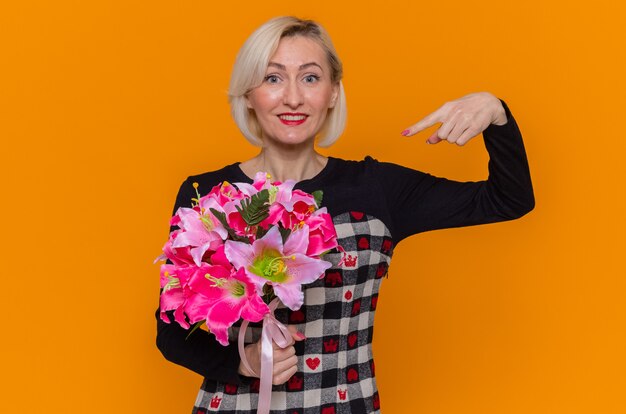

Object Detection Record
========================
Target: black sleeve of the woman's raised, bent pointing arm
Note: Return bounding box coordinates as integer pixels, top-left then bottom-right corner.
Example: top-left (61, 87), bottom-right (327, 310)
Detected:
top-left (375, 101), bottom-right (535, 243)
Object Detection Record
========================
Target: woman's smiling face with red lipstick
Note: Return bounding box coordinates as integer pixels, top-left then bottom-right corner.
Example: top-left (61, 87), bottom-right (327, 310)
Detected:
top-left (247, 36), bottom-right (339, 146)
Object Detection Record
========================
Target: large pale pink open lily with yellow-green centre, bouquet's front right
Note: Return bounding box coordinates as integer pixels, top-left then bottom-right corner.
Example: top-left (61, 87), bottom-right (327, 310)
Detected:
top-left (224, 226), bottom-right (331, 310)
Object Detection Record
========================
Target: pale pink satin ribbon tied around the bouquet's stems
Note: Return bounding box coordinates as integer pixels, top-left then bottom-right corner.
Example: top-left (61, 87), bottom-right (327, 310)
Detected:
top-left (239, 298), bottom-right (292, 414)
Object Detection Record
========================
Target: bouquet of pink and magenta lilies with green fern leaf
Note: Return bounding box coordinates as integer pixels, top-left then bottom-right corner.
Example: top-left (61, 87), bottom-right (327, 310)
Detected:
top-left (157, 173), bottom-right (337, 349)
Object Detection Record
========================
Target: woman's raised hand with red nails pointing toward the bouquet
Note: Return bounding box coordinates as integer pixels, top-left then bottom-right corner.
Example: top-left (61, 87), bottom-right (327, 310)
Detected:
top-left (402, 92), bottom-right (507, 145)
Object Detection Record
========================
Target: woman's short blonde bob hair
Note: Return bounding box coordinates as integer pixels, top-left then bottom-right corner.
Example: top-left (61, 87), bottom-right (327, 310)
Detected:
top-left (228, 16), bottom-right (346, 147)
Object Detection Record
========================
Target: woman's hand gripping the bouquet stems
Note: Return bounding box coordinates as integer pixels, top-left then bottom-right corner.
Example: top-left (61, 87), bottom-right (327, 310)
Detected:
top-left (239, 325), bottom-right (305, 385)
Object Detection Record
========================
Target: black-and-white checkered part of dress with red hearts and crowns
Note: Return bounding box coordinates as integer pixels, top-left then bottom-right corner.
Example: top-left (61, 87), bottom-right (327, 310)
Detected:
top-left (192, 211), bottom-right (393, 414)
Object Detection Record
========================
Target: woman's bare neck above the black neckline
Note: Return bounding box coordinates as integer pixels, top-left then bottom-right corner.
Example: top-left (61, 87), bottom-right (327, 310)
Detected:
top-left (240, 147), bottom-right (328, 181)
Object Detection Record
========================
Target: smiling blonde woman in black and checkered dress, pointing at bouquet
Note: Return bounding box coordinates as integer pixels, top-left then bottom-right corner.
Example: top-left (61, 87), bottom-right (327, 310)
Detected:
top-left (157, 17), bottom-right (534, 414)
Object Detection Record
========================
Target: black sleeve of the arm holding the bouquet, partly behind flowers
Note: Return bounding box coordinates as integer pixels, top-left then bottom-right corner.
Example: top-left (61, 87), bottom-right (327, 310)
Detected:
top-left (156, 179), bottom-right (241, 384)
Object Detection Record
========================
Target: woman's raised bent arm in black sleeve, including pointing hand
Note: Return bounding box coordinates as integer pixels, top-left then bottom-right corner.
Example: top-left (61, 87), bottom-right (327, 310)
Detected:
top-left (376, 93), bottom-right (535, 243)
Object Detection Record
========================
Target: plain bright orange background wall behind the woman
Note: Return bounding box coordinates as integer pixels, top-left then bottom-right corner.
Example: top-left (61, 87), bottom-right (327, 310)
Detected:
top-left (0, 0), bottom-right (626, 414)
